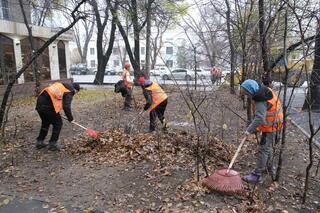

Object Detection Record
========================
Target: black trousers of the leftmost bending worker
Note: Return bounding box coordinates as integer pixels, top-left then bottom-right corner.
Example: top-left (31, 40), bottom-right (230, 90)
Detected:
top-left (37, 110), bottom-right (62, 142)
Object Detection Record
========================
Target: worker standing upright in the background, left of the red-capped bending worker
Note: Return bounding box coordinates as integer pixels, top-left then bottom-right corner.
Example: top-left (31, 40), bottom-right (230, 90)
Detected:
top-left (121, 63), bottom-right (133, 111)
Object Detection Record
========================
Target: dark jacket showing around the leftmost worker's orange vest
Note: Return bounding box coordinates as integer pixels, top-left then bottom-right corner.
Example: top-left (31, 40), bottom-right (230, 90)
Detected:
top-left (36, 83), bottom-right (75, 121)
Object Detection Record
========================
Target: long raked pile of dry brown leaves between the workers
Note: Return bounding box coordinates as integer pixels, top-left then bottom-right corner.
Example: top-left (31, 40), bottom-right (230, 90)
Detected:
top-left (68, 129), bottom-right (235, 170)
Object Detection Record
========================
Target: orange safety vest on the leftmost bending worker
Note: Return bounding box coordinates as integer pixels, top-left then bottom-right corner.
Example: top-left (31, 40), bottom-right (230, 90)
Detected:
top-left (40, 82), bottom-right (70, 113)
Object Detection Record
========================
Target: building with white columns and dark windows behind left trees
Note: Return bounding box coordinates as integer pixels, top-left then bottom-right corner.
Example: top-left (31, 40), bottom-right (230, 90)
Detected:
top-left (0, 0), bottom-right (73, 85)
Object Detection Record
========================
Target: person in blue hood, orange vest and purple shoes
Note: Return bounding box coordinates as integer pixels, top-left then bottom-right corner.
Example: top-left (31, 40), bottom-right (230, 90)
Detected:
top-left (240, 79), bottom-right (283, 183)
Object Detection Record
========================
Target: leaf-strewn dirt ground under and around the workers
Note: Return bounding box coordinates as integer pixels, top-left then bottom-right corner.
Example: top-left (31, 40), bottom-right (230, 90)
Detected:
top-left (0, 88), bottom-right (320, 212)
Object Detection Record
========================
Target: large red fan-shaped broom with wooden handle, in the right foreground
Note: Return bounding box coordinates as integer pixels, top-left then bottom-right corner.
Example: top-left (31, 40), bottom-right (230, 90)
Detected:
top-left (203, 137), bottom-right (247, 194)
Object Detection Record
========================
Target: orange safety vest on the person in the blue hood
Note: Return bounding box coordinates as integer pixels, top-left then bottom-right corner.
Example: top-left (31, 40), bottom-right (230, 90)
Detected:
top-left (257, 88), bottom-right (283, 132)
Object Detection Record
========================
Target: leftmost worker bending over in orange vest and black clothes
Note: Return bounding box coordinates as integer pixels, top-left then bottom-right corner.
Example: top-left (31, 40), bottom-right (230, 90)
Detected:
top-left (36, 82), bottom-right (80, 151)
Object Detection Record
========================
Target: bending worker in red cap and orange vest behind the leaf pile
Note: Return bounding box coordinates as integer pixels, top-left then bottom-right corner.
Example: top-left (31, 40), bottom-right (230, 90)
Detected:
top-left (138, 76), bottom-right (168, 132)
